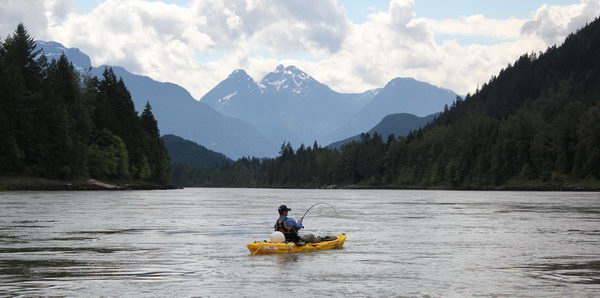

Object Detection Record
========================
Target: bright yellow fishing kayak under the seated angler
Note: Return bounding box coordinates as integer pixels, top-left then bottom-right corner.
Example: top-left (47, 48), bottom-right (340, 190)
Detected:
top-left (248, 234), bottom-right (347, 255)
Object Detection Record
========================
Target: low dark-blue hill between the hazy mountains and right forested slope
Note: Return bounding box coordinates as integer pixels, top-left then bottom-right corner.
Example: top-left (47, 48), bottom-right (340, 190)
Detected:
top-left (327, 113), bottom-right (437, 149)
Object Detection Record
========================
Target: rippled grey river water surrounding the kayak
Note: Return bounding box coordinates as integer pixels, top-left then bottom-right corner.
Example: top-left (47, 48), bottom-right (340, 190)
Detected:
top-left (0, 189), bottom-right (600, 297)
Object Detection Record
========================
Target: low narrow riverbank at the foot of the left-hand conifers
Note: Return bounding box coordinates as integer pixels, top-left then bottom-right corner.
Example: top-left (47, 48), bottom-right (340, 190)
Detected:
top-left (0, 177), bottom-right (178, 191)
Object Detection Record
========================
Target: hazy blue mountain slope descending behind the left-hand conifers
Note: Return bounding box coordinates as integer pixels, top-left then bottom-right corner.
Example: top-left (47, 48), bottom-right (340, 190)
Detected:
top-left (37, 41), bottom-right (278, 158)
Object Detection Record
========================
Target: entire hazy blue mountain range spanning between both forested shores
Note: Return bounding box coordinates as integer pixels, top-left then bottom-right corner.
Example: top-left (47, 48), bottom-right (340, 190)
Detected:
top-left (36, 41), bottom-right (456, 159)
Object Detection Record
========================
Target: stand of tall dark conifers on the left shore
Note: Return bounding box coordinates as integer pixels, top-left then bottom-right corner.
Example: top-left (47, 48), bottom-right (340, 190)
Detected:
top-left (0, 25), bottom-right (169, 184)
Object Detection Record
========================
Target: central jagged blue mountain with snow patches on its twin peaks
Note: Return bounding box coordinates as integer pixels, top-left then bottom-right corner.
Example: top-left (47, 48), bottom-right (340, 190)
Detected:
top-left (201, 65), bottom-right (376, 145)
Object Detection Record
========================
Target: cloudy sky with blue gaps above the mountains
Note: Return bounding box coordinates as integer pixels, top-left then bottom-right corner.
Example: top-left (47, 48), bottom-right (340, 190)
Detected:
top-left (0, 0), bottom-right (600, 99)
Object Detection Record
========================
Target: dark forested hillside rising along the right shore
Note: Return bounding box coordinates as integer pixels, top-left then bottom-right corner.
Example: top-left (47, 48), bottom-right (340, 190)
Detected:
top-left (177, 20), bottom-right (600, 189)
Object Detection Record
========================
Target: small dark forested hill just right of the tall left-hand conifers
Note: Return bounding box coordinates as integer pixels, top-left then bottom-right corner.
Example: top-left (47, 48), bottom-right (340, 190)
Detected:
top-left (161, 135), bottom-right (233, 166)
